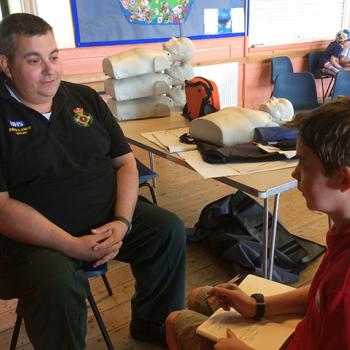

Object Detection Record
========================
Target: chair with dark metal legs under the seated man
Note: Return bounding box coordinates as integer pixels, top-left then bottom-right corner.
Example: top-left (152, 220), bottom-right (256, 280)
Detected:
top-left (10, 262), bottom-right (114, 350)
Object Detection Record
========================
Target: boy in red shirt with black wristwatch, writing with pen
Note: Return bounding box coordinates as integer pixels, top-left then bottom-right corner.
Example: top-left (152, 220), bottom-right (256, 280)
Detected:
top-left (167, 99), bottom-right (350, 350)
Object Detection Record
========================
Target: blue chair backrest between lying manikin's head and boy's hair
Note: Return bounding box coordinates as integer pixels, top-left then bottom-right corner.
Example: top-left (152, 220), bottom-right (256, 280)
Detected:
top-left (272, 72), bottom-right (319, 111)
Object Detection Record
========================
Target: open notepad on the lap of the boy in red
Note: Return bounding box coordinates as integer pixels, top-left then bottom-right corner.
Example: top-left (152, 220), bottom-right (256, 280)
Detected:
top-left (196, 275), bottom-right (302, 350)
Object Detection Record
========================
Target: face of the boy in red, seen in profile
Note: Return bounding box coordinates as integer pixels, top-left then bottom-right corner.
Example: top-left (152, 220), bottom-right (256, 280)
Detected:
top-left (292, 139), bottom-right (339, 214)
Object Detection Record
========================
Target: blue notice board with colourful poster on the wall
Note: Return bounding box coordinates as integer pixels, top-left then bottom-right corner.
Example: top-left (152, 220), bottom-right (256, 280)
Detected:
top-left (71, 0), bottom-right (245, 47)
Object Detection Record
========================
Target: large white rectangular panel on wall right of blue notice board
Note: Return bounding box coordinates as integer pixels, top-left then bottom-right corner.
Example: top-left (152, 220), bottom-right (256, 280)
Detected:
top-left (249, 0), bottom-right (349, 46)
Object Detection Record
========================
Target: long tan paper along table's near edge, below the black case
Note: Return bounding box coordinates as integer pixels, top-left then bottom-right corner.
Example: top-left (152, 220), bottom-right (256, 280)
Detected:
top-left (179, 150), bottom-right (297, 179)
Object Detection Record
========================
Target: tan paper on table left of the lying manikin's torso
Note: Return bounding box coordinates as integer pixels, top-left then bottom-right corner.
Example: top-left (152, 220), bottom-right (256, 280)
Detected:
top-left (141, 127), bottom-right (197, 153)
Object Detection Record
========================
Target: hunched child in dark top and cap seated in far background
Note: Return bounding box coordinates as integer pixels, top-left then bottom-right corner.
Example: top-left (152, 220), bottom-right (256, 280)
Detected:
top-left (319, 31), bottom-right (347, 76)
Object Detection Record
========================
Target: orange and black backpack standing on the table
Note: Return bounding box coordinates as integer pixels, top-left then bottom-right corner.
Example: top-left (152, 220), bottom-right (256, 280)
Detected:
top-left (182, 77), bottom-right (220, 120)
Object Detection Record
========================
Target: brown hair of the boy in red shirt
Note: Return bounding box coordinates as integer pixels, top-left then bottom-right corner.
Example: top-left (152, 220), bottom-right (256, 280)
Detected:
top-left (286, 98), bottom-right (350, 176)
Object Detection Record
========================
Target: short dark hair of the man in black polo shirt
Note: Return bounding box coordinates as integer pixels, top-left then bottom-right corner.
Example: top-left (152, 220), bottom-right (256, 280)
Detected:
top-left (0, 13), bottom-right (53, 61)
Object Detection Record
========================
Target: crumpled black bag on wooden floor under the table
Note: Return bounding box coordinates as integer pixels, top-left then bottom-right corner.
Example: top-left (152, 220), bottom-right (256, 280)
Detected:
top-left (187, 191), bottom-right (325, 283)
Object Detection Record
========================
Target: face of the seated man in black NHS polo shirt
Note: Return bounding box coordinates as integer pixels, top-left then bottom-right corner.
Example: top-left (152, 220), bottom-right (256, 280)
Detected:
top-left (4, 32), bottom-right (62, 106)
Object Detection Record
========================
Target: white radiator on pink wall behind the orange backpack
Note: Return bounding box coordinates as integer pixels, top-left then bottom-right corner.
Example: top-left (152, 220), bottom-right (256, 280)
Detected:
top-left (193, 62), bottom-right (238, 108)
